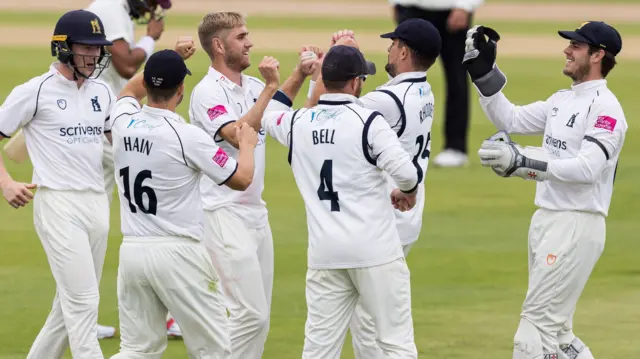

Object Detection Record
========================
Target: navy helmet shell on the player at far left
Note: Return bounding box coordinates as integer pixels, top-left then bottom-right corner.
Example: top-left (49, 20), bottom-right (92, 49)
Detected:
top-left (52, 10), bottom-right (113, 46)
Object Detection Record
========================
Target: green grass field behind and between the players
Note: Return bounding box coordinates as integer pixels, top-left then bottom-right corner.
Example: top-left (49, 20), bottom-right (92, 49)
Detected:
top-left (0, 8), bottom-right (640, 359)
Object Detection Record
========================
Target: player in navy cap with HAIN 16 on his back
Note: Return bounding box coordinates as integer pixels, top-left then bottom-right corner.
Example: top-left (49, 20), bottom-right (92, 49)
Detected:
top-left (110, 46), bottom-right (258, 359)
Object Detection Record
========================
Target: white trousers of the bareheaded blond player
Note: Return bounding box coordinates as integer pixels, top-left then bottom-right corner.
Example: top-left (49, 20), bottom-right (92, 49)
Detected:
top-left (202, 208), bottom-right (273, 359)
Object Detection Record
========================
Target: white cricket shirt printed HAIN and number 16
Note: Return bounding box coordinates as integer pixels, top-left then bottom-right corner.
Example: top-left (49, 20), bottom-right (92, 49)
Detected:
top-left (110, 97), bottom-right (238, 240)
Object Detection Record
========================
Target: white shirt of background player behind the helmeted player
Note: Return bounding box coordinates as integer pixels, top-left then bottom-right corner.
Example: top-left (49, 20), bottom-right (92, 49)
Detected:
top-left (86, 0), bottom-right (135, 95)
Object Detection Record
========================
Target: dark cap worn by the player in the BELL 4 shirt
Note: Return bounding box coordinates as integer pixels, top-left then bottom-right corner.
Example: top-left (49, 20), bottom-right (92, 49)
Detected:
top-left (322, 45), bottom-right (376, 81)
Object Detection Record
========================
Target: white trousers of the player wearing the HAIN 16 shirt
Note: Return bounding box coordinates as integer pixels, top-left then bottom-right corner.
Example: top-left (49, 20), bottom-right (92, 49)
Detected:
top-left (111, 237), bottom-right (231, 359)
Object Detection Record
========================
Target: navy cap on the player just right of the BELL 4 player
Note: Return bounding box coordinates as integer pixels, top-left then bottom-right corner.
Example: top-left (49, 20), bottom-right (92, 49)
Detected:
top-left (380, 18), bottom-right (442, 58)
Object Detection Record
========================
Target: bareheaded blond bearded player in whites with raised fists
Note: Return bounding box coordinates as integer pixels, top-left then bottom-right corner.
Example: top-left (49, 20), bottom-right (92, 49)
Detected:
top-left (189, 12), bottom-right (313, 359)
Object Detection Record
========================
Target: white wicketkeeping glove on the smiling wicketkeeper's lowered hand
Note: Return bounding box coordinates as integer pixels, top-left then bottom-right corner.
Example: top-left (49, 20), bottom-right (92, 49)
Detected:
top-left (478, 131), bottom-right (548, 181)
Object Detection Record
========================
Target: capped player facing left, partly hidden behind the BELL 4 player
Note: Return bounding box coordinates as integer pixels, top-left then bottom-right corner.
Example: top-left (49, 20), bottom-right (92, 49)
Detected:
top-left (309, 19), bottom-right (442, 358)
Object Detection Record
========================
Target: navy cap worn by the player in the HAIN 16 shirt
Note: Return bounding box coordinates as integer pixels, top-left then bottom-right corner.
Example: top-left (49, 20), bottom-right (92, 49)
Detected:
top-left (144, 50), bottom-right (191, 89)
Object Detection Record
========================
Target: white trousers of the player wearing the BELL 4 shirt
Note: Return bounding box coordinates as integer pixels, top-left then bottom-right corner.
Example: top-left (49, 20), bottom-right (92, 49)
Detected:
top-left (302, 258), bottom-right (418, 359)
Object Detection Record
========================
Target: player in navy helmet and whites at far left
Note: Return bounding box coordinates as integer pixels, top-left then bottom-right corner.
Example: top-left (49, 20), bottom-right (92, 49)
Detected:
top-left (0, 10), bottom-right (115, 359)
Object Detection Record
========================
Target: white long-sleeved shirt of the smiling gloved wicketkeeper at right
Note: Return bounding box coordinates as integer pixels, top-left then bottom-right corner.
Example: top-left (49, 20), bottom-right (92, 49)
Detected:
top-left (480, 80), bottom-right (628, 216)
